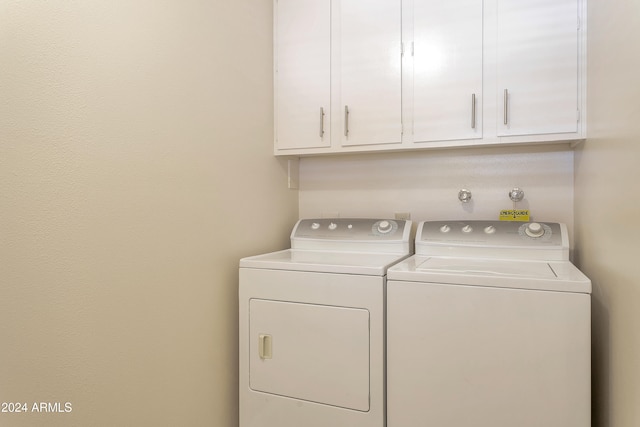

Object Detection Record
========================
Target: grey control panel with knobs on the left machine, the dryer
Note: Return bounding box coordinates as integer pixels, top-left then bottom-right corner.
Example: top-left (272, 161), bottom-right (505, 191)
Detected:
top-left (291, 218), bottom-right (410, 241)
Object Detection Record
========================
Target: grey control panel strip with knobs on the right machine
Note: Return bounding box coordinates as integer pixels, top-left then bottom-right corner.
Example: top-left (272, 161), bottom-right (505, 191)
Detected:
top-left (418, 221), bottom-right (563, 247)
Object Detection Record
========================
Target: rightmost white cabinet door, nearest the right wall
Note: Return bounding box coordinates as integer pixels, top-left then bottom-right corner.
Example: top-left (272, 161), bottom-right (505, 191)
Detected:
top-left (497, 0), bottom-right (578, 136)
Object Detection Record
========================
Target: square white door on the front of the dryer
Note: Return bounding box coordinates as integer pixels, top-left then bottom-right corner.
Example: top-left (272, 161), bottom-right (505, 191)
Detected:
top-left (249, 299), bottom-right (369, 411)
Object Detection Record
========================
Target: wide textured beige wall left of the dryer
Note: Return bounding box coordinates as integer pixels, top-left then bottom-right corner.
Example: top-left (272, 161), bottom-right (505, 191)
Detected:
top-left (0, 0), bottom-right (297, 427)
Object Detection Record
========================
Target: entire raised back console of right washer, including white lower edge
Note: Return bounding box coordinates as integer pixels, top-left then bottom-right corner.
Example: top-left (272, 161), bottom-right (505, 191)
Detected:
top-left (416, 220), bottom-right (569, 260)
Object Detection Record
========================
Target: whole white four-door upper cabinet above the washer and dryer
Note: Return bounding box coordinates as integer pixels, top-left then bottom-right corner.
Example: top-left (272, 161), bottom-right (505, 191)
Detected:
top-left (274, 0), bottom-right (587, 155)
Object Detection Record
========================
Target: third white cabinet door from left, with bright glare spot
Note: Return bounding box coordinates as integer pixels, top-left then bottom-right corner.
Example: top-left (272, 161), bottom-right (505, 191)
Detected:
top-left (413, 0), bottom-right (482, 142)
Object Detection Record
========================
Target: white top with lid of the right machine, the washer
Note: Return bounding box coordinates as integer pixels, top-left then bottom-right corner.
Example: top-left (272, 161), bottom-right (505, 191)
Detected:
top-left (387, 255), bottom-right (591, 293)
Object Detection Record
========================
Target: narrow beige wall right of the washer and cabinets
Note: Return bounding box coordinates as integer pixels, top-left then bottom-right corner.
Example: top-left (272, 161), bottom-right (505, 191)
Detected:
top-left (575, 0), bottom-right (640, 427)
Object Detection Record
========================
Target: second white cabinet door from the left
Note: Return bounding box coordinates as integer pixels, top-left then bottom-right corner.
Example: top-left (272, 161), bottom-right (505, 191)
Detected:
top-left (336, 0), bottom-right (402, 146)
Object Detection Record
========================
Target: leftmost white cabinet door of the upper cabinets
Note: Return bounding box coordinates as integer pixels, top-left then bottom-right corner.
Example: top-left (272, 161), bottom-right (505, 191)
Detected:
top-left (275, 0), bottom-right (331, 150)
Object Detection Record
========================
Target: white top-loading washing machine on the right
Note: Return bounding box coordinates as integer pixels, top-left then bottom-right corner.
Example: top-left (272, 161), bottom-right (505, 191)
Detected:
top-left (387, 221), bottom-right (591, 427)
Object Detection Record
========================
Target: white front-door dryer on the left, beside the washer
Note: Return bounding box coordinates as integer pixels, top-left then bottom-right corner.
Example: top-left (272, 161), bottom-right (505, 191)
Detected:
top-left (239, 219), bottom-right (411, 427)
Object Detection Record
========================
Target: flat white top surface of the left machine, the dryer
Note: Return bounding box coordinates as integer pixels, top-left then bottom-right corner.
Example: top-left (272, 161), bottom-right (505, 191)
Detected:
top-left (240, 249), bottom-right (408, 276)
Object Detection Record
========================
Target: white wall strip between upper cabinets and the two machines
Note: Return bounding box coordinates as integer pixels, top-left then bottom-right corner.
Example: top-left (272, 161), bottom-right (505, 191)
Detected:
top-left (300, 144), bottom-right (573, 241)
